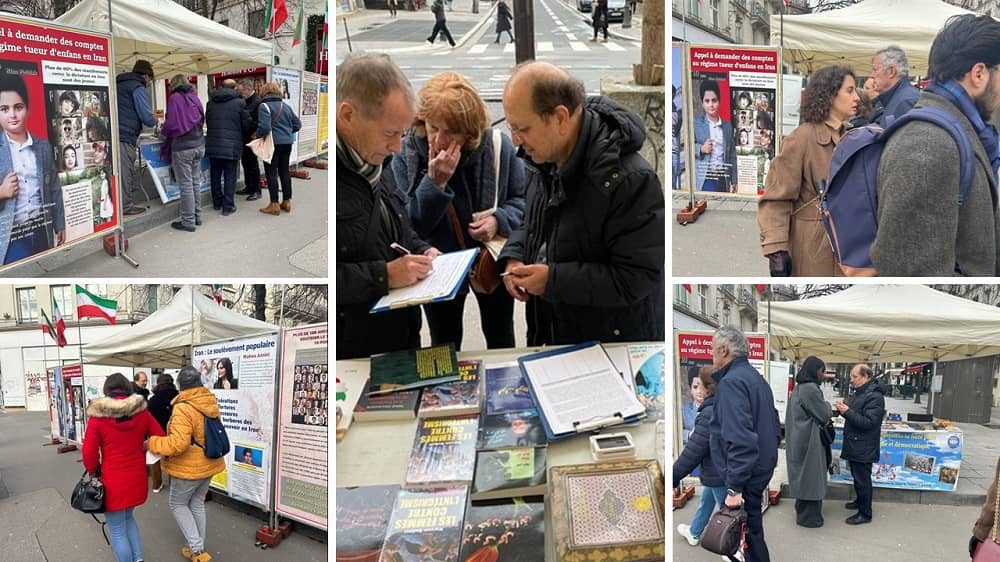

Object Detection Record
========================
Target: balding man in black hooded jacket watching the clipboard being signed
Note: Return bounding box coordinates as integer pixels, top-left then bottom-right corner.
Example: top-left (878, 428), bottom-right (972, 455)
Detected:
top-left (498, 61), bottom-right (665, 345)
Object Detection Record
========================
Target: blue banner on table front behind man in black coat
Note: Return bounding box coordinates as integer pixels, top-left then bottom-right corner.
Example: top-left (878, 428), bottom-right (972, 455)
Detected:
top-left (830, 427), bottom-right (963, 492)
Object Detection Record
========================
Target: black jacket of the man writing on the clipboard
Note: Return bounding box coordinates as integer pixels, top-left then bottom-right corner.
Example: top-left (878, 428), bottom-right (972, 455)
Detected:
top-left (335, 150), bottom-right (430, 359)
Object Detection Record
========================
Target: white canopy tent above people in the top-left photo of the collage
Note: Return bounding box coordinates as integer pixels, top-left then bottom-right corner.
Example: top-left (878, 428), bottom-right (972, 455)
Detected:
top-left (56, 0), bottom-right (272, 78)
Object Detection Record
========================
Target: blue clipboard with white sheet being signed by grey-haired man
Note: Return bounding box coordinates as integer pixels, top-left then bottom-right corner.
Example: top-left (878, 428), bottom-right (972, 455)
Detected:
top-left (370, 248), bottom-right (479, 313)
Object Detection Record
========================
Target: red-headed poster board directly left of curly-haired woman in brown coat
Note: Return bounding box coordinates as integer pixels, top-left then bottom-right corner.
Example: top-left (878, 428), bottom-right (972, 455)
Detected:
top-left (683, 45), bottom-right (781, 195)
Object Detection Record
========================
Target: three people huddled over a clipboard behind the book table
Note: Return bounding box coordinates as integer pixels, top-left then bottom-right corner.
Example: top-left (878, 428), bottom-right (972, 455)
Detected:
top-left (336, 53), bottom-right (665, 358)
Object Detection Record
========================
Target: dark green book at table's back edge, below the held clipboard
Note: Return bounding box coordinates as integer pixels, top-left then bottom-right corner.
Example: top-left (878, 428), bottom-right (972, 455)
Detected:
top-left (368, 343), bottom-right (459, 394)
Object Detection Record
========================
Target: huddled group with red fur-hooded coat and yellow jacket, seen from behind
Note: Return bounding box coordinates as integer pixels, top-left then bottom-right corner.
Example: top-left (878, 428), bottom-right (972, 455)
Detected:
top-left (83, 366), bottom-right (226, 562)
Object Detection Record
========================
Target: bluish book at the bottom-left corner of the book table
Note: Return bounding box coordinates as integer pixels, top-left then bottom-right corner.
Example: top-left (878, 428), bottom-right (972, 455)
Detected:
top-left (336, 484), bottom-right (399, 562)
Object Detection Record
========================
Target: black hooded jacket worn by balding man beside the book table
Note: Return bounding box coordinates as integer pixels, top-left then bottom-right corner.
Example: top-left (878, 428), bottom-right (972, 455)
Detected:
top-left (498, 96), bottom-right (665, 345)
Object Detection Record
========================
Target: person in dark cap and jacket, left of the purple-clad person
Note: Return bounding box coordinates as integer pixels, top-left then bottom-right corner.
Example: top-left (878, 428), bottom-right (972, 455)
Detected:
top-left (115, 59), bottom-right (156, 215)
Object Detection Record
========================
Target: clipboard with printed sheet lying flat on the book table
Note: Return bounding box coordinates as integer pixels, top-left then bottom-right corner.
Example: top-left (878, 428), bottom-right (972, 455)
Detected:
top-left (517, 342), bottom-right (646, 441)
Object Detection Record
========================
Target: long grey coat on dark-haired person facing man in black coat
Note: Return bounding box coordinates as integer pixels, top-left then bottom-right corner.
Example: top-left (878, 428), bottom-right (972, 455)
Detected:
top-left (785, 383), bottom-right (833, 501)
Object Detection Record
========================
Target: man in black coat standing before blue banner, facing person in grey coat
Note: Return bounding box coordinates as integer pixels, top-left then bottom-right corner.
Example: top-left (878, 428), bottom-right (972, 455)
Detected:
top-left (834, 363), bottom-right (885, 525)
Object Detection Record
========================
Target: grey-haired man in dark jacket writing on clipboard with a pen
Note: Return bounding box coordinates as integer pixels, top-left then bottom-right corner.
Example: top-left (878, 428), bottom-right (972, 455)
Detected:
top-left (336, 53), bottom-right (440, 359)
